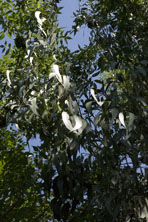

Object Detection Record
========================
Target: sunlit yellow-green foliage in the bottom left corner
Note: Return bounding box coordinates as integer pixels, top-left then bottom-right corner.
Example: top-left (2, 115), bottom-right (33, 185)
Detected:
top-left (0, 129), bottom-right (51, 222)
